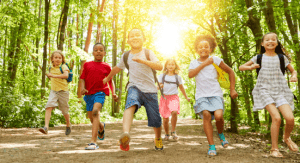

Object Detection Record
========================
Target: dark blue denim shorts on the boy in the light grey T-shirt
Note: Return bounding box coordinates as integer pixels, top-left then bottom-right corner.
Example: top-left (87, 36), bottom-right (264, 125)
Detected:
top-left (125, 86), bottom-right (161, 128)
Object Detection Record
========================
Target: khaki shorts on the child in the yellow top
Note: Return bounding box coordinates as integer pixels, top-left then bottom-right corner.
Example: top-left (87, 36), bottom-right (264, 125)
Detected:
top-left (45, 90), bottom-right (69, 115)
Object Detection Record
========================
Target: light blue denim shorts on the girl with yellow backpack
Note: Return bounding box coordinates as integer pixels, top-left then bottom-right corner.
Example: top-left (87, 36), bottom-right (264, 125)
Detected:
top-left (194, 96), bottom-right (224, 120)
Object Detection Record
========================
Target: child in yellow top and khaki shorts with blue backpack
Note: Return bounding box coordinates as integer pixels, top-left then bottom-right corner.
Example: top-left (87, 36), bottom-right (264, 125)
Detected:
top-left (39, 50), bottom-right (71, 135)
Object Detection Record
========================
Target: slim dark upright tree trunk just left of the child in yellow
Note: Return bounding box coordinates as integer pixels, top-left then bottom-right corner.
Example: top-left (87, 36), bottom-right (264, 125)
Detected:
top-left (41, 0), bottom-right (50, 99)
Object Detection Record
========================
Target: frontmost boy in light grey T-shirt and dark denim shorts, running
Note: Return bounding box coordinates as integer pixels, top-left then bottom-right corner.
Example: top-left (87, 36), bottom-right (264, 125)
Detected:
top-left (103, 28), bottom-right (163, 151)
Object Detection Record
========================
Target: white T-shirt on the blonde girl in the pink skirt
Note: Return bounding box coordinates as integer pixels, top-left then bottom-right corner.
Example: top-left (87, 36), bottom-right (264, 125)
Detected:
top-left (158, 74), bottom-right (182, 95)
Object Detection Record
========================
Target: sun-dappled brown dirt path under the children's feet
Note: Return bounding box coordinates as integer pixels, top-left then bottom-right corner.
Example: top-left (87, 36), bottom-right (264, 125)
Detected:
top-left (0, 119), bottom-right (300, 163)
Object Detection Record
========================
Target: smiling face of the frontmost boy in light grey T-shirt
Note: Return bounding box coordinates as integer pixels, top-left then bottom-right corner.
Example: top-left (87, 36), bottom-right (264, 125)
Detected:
top-left (127, 29), bottom-right (145, 49)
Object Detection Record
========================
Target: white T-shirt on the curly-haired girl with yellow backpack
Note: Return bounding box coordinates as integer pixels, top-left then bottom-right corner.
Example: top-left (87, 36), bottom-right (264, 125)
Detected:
top-left (189, 56), bottom-right (223, 100)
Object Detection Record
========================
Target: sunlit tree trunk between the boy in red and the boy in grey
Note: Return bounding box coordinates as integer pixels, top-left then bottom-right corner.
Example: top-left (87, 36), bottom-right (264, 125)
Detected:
top-left (112, 0), bottom-right (119, 116)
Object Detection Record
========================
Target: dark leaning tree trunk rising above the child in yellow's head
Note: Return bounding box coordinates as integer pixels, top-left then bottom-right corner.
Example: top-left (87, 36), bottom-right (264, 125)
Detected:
top-left (57, 0), bottom-right (70, 51)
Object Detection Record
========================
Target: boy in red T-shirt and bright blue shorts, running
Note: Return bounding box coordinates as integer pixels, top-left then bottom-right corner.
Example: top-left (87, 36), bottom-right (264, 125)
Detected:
top-left (80, 43), bottom-right (118, 150)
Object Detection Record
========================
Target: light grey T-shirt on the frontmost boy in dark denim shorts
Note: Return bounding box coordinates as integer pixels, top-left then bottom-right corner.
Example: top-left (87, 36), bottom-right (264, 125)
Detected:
top-left (117, 49), bottom-right (159, 93)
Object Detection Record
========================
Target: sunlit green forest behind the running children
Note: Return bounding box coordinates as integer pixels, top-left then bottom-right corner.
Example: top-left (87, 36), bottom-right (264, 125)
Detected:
top-left (0, 0), bottom-right (300, 139)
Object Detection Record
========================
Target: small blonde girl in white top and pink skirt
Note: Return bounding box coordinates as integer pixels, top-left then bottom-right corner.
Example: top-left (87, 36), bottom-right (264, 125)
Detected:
top-left (158, 59), bottom-right (190, 141)
